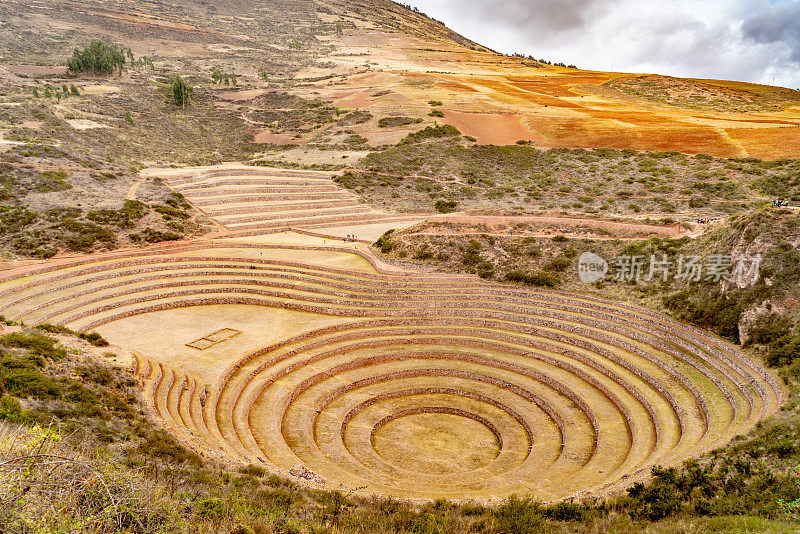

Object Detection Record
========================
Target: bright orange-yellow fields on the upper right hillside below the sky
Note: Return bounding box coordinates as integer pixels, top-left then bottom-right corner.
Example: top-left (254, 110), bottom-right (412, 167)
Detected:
top-left (301, 34), bottom-right (800, 159)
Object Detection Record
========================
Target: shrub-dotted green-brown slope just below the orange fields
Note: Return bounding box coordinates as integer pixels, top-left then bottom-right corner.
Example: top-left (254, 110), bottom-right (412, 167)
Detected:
top-left (347, 143), bottom-right (760, 220)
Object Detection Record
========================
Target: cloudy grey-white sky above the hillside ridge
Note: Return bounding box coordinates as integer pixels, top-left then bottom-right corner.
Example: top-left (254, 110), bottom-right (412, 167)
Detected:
top-left (405, 0), bottom-right (800, 88)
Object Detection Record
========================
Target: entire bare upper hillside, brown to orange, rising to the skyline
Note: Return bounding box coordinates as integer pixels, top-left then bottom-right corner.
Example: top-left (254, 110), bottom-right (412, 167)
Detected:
top-left (0, 0), bottom-right (800, 159)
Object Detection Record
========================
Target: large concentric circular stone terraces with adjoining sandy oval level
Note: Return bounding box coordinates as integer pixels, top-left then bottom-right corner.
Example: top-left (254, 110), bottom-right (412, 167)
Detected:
top-left (0, 242), bottom-right (781, 500)
